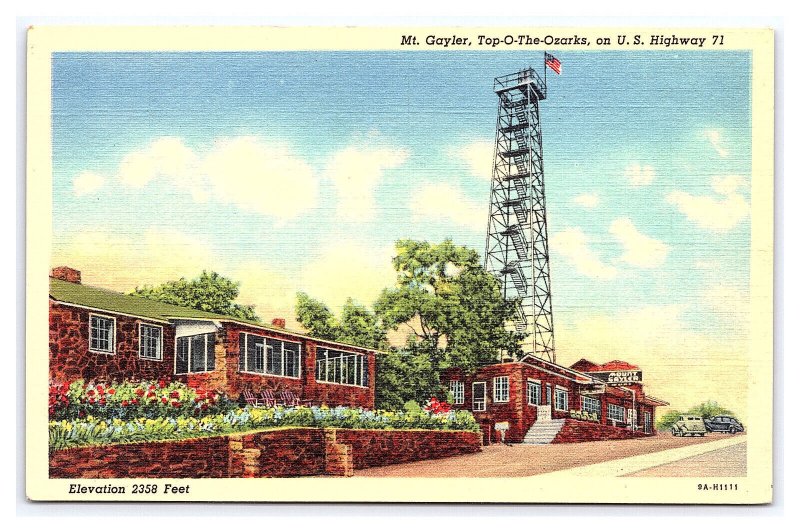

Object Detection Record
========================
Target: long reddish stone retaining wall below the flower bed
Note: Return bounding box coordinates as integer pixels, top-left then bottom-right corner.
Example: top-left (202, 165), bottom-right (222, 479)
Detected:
top-left (50, 428), bottom-right (481, 478)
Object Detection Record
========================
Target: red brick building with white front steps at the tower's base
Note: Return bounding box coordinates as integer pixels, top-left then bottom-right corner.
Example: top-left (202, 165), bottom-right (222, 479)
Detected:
top-left (442, 356), bottom-right (668, 443)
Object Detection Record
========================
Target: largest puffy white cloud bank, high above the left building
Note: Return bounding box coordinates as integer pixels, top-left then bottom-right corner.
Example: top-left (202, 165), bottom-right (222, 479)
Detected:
top-left (82, 137), bottom-right (318, 220)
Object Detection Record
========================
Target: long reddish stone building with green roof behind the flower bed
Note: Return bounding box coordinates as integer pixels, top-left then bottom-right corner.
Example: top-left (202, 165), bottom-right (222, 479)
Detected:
top-left (49, 267), bottom-right (377, 408)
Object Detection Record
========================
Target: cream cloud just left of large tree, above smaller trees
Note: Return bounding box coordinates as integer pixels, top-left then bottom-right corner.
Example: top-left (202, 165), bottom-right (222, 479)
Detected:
top-left (292, 241), bottom-right (396, 313)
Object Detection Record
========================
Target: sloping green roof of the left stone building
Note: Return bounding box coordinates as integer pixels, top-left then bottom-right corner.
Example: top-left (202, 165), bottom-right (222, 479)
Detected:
top-left (50, 277), bottom-right (245, 327)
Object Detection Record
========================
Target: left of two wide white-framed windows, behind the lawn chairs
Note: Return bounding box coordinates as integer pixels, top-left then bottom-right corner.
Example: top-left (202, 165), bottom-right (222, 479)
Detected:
top-left (239, 333), bottom-right (300, 377)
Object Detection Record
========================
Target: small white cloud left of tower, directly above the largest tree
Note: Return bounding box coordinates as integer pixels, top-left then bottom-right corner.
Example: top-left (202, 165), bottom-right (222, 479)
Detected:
top-left (409, 184), bottom-right (488, 230)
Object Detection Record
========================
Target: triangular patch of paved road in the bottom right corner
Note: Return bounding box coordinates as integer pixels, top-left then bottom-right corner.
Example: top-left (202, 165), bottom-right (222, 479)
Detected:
top-left (625, 443), bottom-right (747, 477)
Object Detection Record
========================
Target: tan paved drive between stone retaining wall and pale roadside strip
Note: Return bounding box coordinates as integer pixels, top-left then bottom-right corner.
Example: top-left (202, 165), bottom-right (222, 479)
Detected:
top-left (355, 433), bottom-right (738, 477)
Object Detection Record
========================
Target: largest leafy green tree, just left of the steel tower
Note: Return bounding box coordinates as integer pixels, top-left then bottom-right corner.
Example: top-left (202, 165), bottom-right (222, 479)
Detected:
top-left (375, 240), bottom-right (522, 372)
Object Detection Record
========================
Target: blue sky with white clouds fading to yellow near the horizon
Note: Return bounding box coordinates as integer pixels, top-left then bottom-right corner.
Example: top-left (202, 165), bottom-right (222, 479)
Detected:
top-left (52, 50), bottom-right (751, 412)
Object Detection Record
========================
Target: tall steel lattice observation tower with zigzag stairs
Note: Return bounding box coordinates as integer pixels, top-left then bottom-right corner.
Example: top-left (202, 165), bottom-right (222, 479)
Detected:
top-left (485, 68), bottom-right (555, 362)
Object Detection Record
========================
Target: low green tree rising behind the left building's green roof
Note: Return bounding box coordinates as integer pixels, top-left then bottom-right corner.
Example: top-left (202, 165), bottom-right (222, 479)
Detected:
top-left (131, 270), bottom-right (260, 321)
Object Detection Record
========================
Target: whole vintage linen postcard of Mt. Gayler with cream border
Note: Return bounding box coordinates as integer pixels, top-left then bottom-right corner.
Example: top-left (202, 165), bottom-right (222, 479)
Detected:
top-left (26, 26), bottom-right (774, 504)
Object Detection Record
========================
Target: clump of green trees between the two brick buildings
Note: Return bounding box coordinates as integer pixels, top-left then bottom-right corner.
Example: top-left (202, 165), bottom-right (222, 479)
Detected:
top-left (296, 240), bottom-right (521, 409)
